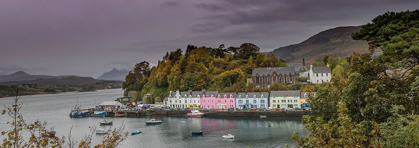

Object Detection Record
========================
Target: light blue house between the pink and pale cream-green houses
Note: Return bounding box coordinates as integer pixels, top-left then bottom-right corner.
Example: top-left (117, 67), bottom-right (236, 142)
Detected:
top-left (236, 92), bottom-right (269, 109)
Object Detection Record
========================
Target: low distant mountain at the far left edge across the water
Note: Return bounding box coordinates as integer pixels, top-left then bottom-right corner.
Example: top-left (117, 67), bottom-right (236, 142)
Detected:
top-left (0, 71), bottom-right (54, 82)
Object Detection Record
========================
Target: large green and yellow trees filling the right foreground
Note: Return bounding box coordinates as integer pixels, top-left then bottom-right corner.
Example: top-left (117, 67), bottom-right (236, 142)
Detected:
top-left (293, 10), bottom-right (419, 147)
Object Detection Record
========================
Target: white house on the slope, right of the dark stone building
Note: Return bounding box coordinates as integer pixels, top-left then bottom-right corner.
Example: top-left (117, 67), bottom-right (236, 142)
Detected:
top-left (308, 65), bottom-right (332, 84)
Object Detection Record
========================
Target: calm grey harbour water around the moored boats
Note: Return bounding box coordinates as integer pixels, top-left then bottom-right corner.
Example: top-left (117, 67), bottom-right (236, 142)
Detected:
top-left (0, 89), bottom-right (308, 148)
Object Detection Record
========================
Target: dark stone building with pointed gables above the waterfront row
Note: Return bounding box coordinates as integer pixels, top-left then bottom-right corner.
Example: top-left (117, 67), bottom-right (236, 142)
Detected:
top-left (252, 67), bottom-right (297, 88)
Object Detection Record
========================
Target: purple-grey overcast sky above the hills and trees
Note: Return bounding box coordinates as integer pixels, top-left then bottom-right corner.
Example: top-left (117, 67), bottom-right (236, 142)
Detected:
top-left (0, 0), bottom-right (419, 78)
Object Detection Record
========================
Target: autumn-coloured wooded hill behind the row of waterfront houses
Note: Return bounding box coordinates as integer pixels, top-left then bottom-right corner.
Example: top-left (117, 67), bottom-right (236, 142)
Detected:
top-left (122, 43), bottom-right (287, 101)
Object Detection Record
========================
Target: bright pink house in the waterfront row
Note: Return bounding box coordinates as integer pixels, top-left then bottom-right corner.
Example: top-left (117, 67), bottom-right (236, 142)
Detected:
top-left (200, 91), bottom-right (236, 109)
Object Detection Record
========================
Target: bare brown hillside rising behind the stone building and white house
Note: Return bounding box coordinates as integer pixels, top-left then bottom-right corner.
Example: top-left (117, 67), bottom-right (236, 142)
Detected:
top-left (267, 26), bottom-right (378, 63)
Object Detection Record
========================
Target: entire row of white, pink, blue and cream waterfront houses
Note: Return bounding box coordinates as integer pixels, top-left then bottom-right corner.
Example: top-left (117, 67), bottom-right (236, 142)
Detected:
top-left (164, 91), bottom-right (315, 110)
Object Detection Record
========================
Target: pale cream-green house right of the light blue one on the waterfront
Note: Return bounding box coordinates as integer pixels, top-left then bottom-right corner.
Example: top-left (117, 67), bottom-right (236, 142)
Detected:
top-left (269, 90), bottom-right (301, 108)
